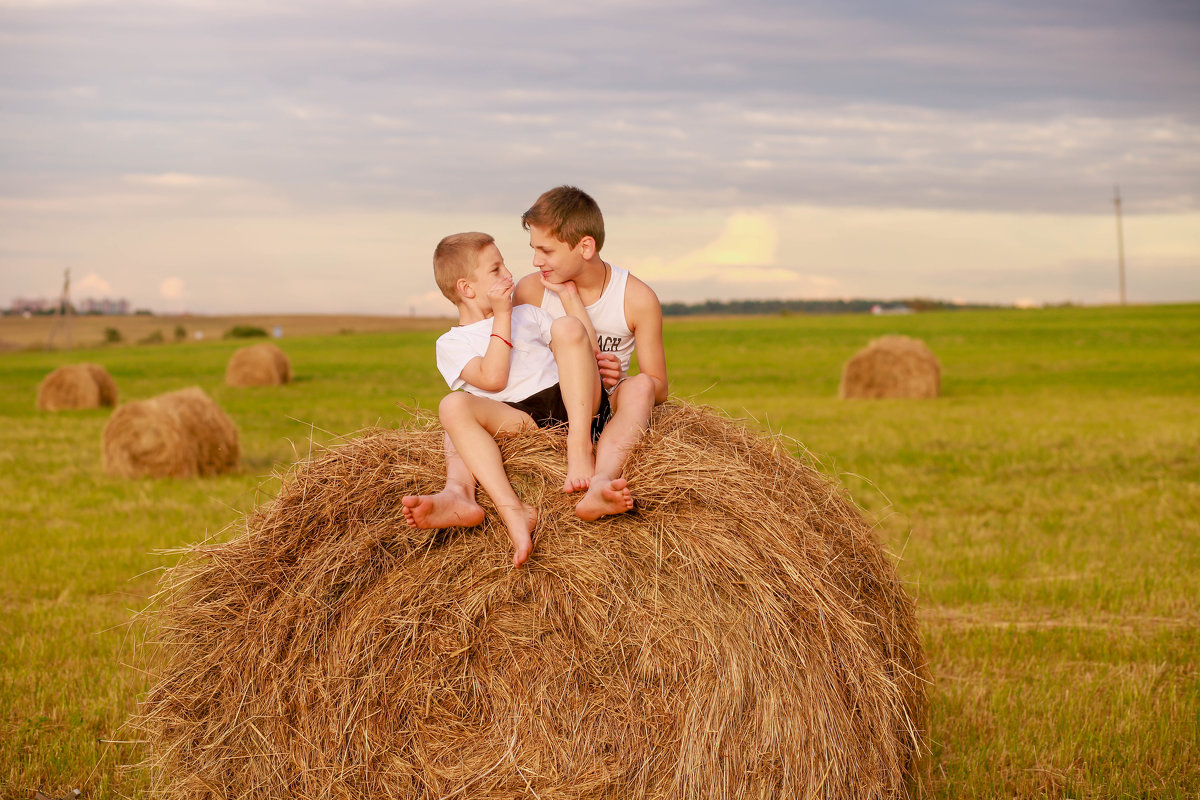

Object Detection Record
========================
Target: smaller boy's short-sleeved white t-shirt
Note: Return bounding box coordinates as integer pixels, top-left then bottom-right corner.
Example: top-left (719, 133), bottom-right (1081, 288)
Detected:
top-left (436, 305), bottom-right (558, 403)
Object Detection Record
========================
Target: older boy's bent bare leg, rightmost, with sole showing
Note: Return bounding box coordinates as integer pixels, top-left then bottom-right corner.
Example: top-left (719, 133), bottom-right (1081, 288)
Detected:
top-left (575, 375), bottom-right (654, 521)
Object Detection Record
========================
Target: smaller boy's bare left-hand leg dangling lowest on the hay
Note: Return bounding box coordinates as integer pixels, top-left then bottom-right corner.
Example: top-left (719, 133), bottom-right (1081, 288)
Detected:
top-left (438, 392), bottom-right (538, 566)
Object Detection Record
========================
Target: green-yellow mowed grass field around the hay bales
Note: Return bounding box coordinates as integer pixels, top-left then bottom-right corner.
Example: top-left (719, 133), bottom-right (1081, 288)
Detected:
top-left (0, 305), bottom-right (1200, 799)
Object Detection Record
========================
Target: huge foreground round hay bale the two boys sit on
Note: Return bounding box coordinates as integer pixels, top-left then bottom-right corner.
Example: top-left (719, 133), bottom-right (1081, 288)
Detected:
top-left (136, 405), bottom-right (928, 800)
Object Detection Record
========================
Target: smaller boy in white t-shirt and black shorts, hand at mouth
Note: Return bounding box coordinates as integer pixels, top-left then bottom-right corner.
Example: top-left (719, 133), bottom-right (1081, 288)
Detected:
top-left (402, 233), bottom-right (607, 567)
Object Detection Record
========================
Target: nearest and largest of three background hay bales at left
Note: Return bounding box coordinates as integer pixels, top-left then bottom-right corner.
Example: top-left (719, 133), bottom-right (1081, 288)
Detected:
top-left (103, 386), bottom-right (240, 477)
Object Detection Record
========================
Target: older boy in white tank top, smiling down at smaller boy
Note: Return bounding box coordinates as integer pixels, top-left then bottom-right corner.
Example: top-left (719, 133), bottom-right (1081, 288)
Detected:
top-left (515, 186), bottom-right (667, 519)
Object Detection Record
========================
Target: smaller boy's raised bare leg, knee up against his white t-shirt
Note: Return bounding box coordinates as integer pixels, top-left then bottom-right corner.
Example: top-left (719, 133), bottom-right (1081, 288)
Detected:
top-left (550, 317), bottom-right (601, 492)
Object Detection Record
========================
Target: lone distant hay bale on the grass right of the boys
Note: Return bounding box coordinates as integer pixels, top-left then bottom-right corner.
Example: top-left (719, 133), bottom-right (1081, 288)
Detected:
top-left (838, 336), bottom-right (942, 399)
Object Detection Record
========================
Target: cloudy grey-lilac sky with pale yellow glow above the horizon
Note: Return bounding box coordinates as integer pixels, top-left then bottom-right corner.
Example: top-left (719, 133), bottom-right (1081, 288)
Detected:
top-left (0, 0), bottom-right (1200, 314)
